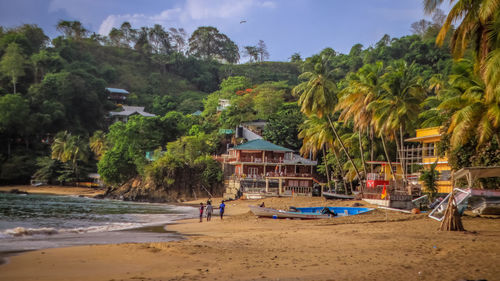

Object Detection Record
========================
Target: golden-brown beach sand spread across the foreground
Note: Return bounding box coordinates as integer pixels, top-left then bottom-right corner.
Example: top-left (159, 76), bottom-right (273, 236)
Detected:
top-left (0, 187), bottom-right (500, 281)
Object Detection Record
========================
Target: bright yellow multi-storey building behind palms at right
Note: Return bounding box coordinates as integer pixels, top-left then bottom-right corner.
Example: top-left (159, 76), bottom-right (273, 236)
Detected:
top-left (406, 127), bottom-right (452, 193)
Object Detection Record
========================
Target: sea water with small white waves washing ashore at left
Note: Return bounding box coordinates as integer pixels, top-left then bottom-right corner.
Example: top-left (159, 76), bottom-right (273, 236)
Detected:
top-left (0, 193), bottom-right (197, 252)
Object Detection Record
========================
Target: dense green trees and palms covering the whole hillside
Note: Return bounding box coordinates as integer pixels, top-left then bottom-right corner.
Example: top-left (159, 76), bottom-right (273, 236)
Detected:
top-left (0, 1), bottom-right (500, 195)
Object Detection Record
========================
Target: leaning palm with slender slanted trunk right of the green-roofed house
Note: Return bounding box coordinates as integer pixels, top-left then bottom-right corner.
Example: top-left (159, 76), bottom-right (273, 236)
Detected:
top-left (293, 54), bottom-right (363, 187)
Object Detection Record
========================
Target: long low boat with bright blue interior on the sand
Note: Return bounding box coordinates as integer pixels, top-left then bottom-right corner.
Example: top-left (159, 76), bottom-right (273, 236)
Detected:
top-left (249, 203), bottom-right (373, 219)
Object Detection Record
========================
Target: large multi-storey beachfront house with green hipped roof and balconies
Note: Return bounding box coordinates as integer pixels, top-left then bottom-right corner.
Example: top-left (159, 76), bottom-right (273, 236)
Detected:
top-left (215, 139), bottom-right (317, 199)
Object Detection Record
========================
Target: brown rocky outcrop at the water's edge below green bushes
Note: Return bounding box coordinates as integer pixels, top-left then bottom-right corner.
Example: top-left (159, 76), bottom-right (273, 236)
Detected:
top-left (104, 169), bottom-right (224, 203)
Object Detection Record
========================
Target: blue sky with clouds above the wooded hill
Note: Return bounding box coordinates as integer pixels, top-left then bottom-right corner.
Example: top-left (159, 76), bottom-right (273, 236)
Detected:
top-left (0, 0), bottom-right (447, 61)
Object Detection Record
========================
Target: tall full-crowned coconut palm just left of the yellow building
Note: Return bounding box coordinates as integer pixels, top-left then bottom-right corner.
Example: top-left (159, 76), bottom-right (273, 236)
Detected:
top-left (367, 60), bottom-right (425, 181)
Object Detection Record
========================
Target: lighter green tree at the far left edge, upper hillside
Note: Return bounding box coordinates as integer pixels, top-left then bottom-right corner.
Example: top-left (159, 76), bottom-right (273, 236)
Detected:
top-left (0, 43), bottom-right (26, 94)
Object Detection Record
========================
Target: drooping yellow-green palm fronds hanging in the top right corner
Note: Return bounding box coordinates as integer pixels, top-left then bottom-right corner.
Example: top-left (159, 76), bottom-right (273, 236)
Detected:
top-left (424, 0), bottom-right (500, 73)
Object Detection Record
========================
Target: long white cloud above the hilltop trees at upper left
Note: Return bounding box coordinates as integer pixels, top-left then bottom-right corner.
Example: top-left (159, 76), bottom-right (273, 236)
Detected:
top-left (96, 0), bottom-right (276, 35)
